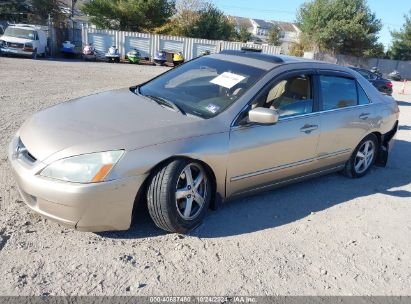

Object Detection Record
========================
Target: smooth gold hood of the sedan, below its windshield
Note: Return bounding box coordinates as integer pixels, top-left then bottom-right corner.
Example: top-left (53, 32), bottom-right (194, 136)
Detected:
top-left (19, 89), bottom-right (222, 163)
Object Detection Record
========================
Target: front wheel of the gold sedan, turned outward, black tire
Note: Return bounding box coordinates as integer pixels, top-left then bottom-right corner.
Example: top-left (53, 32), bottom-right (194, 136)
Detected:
top-left (147, 159), bottom-right (212, 233)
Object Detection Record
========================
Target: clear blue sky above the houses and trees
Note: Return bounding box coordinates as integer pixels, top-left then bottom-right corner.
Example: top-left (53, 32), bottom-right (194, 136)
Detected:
top-left (213, 0), bottom-right (411, 48)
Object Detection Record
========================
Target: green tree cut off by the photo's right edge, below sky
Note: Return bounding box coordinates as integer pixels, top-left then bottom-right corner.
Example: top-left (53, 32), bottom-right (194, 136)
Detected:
top-left (389, 11), bottom-right (411, 60)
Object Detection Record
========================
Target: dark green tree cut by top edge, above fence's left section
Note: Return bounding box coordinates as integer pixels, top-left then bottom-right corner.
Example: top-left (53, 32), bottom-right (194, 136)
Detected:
top-left (82, 0), bottom-right (175, 31)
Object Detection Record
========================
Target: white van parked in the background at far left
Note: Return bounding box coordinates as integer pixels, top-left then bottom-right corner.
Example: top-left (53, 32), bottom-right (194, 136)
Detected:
top-left (0, 24), bottom-right (47, 59)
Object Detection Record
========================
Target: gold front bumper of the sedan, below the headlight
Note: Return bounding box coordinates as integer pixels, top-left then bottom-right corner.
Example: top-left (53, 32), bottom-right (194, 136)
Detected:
top-left (9, 140), bottom-right (146, 232)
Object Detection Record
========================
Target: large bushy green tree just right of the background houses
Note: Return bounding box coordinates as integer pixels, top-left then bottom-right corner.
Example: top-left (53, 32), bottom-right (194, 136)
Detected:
top-left (297, 0), bottom-right (382, 56)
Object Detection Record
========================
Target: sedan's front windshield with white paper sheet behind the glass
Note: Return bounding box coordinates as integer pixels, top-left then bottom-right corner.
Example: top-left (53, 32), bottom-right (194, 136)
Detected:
top-left (139, 57), bottom-right (265, 118)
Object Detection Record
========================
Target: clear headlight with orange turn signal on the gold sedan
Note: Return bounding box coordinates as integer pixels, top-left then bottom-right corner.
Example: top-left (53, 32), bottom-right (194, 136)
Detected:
top-left (40, 150), bottom-right (124, 183)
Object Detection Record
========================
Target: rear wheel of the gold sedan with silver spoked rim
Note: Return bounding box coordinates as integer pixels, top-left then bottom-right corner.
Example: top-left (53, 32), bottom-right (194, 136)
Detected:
top-left (343, 134), bottom-right (379, 178)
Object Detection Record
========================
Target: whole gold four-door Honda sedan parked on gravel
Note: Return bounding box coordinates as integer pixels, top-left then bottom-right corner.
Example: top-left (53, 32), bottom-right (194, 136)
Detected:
top-left (9, 50), bottom-right (399, 233)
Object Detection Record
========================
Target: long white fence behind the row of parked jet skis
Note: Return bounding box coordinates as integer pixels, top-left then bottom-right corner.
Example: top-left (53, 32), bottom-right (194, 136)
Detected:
top-left (82, 27), bottom-right (281, 60)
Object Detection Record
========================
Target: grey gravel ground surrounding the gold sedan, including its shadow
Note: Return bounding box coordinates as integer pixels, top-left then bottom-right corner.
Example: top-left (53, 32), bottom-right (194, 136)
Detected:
top-left (0, 58), bottom-right (411, 295)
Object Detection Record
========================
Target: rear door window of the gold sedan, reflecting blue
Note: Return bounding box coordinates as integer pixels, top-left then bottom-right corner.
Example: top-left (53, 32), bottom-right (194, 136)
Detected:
top-left (319, 75), bottom-right (358, 111)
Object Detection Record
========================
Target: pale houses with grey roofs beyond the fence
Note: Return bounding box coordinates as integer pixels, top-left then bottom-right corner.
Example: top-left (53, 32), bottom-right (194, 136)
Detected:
top-left (230, 16), bottom-right (301, 54)
